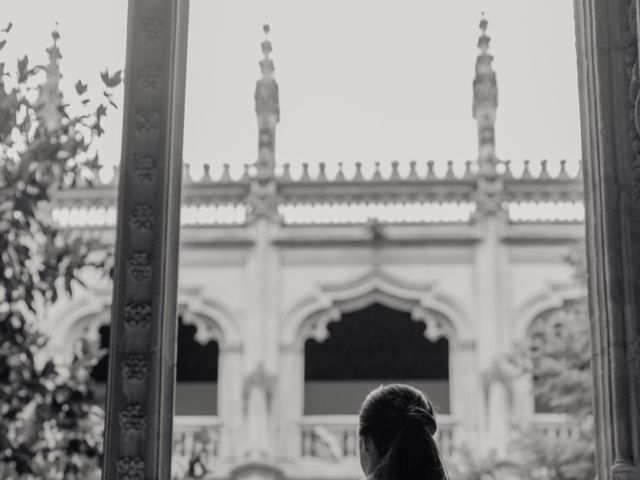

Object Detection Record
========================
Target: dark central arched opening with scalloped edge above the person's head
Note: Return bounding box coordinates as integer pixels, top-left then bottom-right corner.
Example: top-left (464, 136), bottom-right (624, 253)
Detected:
top-left (304, 303), bottom-right (449, 415)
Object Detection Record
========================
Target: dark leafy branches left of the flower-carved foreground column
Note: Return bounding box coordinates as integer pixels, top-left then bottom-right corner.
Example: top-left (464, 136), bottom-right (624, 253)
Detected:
top-left (0, 24), bottom-right (121, 480)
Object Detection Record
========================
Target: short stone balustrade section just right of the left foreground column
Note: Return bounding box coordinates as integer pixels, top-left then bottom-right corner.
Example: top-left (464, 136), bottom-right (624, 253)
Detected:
top-left (172, 416), bottom-right (222, 479)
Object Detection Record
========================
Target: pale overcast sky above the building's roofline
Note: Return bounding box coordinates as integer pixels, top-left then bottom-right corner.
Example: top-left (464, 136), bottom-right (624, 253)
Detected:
top-left (5, 0), bottom-right (580, 180)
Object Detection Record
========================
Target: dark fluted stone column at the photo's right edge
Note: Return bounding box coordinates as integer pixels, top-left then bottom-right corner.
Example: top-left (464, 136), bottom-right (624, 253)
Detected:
top-left (575, 0), bottom-right (640, 479)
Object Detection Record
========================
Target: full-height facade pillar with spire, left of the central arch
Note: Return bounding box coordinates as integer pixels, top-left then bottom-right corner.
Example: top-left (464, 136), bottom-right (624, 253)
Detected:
top-left (230, 25), bottom-right (282, 480)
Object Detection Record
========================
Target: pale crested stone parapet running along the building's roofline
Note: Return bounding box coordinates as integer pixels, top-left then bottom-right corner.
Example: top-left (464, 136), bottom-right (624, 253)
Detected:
top-left (48, 160), bottom-right (584, 229)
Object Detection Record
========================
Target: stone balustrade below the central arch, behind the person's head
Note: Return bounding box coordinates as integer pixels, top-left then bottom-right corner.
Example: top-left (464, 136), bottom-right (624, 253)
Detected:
top-left (300, 415), bottom-right (455, 464)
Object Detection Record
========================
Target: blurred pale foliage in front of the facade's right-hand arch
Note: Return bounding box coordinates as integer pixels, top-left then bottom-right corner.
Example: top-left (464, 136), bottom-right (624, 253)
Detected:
top-left (455, 246), bottom-right (596, 480)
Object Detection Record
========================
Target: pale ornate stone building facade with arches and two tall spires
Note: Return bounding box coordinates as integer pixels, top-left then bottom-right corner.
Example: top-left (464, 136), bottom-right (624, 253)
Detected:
top-left (47, 15), bottom-right (586, 479)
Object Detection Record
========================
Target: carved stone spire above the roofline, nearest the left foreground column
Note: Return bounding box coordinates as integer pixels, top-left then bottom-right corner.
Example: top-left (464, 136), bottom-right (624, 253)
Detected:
top-left (255, 24), bottom-right (280, 181)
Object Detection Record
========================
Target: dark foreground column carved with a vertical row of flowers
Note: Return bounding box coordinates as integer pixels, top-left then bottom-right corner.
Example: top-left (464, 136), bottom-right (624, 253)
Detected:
top-left (103, 0), bottom-right (188, 480)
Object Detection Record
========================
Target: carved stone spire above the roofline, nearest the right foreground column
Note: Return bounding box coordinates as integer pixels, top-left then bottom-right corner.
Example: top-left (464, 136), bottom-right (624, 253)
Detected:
top-left (473, 12), bottom-right (498, 175)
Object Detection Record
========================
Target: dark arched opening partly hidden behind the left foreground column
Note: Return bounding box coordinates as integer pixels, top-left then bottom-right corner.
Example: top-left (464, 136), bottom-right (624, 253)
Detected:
top-left (91, 316), bottom-right (219, 415)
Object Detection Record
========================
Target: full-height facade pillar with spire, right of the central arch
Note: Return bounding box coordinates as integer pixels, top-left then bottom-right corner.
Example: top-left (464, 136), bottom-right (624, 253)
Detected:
top-left (472, 15), bottom-right (510, 455)
